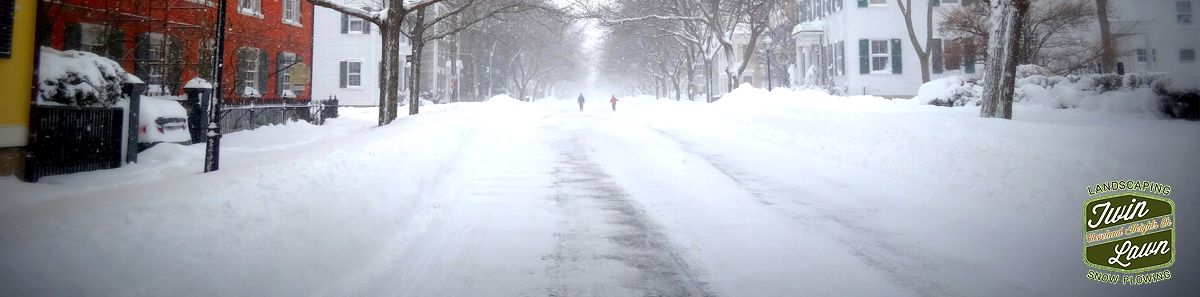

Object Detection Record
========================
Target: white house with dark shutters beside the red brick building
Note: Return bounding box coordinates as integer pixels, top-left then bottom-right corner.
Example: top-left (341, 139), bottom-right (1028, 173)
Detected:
top-left (312, 0), bottom-right (410, 105)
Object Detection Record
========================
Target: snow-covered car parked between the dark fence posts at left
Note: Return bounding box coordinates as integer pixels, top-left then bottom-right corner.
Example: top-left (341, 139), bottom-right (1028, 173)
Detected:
top-left (138, 96), bottom-right (192, 150)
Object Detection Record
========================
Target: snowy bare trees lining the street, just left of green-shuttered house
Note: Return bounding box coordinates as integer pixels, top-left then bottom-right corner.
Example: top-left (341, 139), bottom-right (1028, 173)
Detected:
top-left (575, 0), bottom-right (790, 101)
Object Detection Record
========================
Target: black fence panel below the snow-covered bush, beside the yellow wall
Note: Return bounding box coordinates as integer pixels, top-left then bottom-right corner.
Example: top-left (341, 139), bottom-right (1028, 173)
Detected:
top-left (25, 105), bottom-right (126, 182)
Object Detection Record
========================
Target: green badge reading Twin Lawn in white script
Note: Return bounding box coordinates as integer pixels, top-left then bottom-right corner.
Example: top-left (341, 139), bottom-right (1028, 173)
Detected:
top-left (1084, 189), bottom-right (1177, 273)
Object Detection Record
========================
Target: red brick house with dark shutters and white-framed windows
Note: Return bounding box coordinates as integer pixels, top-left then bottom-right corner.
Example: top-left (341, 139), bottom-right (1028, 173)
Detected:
top-left (38, 0), bottom-right (313, 101)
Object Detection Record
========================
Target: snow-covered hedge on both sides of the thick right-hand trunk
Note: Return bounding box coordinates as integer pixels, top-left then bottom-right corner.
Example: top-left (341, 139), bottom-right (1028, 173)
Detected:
top-left (917, 65), bottom-right (1180, 117)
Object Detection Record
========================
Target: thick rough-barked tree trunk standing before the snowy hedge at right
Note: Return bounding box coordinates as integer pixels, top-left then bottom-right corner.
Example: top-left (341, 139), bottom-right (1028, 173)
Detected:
top-left (979, 0), bottom-right (1028, 119)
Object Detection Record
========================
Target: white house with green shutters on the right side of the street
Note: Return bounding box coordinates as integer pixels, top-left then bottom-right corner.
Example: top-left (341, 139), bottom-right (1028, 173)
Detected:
top-left (793, 0), bottom-right (982, 97)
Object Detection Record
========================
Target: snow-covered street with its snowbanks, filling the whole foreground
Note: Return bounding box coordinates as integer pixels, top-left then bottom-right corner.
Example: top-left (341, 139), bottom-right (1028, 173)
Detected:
top-left (0, 90), bottom-right (1200, 296)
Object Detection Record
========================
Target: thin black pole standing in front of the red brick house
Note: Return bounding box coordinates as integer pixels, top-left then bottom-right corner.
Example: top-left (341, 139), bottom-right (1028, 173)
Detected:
top-left (204, 0), bottom-right (227, 172)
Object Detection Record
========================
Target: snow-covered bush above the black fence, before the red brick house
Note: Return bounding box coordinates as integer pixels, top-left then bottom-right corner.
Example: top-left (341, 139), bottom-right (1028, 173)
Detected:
top-left (37, 47), bottom-right (128, 107)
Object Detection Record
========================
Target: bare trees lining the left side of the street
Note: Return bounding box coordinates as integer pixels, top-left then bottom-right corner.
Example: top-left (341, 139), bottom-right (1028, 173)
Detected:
top-left (308, 0), bottom-right (578, 126)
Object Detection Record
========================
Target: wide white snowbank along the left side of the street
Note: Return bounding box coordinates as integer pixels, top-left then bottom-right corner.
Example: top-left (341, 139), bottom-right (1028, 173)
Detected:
top-left (0, 97), bottom-right (542, 296)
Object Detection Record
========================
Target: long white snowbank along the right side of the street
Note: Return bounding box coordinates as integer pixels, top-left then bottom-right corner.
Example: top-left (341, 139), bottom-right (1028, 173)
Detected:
top-left (637, 87), bottom-right (1200, 228)
